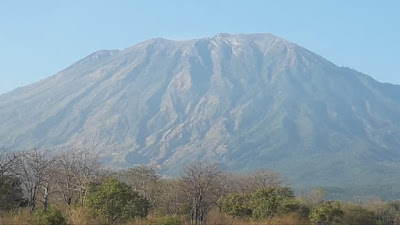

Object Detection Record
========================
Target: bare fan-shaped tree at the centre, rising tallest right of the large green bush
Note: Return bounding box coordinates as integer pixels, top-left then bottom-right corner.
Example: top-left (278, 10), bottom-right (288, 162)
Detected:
top-left (180, 162), bottom-right (223, 224)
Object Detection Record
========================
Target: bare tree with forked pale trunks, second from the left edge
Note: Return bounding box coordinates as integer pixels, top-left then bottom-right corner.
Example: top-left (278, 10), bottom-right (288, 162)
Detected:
top-left (16, 149), bottom-right (54, 211)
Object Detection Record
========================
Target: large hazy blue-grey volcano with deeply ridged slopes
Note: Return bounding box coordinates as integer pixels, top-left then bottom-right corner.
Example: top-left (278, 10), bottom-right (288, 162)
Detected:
top-left (0, 34), bottom-right (400, 197)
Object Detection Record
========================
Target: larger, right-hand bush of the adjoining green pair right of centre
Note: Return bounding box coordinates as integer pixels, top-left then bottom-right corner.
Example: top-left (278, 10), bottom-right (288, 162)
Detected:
top-left (252, 187), bottom-right (300, 219)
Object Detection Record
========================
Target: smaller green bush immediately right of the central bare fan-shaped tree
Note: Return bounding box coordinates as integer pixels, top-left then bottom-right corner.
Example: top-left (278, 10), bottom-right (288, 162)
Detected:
top-left (218, 193), bottom-right (253, 217)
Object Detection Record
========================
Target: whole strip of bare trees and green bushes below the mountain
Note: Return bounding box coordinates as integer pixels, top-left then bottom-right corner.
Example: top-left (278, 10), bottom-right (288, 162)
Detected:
top-left (0, 148), bottom-right (400, 225)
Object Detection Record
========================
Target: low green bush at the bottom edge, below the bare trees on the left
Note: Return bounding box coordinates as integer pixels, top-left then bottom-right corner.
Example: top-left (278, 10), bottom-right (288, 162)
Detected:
top-left (31, 206), bottom-right (67, 225)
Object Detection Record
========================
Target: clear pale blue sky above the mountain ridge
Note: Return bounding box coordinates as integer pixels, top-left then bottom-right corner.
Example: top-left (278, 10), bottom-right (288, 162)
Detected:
top-left (0, 0), bottom-right (400, 93)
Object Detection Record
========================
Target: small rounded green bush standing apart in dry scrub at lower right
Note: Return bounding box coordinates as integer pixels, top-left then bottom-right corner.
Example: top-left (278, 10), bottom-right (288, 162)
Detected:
top-left (310, 201), bottom-right (344, 225)
